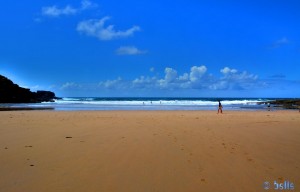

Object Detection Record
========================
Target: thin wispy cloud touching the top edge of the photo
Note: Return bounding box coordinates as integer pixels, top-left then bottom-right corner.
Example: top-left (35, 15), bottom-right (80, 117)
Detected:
top-left (42, 0), bottom-right (97, 17)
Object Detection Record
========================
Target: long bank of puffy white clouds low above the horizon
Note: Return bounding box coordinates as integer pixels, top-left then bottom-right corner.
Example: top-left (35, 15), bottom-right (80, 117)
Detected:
top-left (62, 65), bottom-right (262, 90)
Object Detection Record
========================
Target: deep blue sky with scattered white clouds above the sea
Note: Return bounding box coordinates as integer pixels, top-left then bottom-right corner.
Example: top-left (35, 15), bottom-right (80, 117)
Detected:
top-left (0, 0), bottom-right (300, 98)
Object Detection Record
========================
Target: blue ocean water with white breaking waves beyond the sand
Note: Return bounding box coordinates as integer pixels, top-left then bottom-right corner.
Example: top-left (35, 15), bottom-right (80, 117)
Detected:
top-left (6, 97), bottom-right (275, 111)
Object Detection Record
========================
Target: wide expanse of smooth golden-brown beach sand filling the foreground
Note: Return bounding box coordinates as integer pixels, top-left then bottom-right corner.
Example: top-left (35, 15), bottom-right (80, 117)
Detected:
top-left (0, 111), bottom-right (300, 192)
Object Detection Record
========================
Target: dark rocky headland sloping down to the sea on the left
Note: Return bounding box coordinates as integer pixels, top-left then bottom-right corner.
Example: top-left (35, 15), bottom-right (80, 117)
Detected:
top-left (0, 75), bottom-right (56, 103)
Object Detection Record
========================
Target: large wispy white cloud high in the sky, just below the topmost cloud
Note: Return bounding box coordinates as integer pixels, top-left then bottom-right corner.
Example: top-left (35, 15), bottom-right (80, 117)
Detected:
top-left (77, 17), bottom-right (140, 41)
